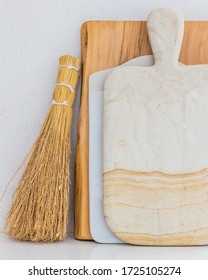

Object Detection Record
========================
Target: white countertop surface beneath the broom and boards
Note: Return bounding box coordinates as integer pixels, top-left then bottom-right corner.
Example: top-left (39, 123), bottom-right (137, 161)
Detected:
top-left (0, 234), bottom-right (208, 260)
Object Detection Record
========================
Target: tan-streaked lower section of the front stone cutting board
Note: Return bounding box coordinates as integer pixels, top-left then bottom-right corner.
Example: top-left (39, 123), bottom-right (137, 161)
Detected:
top-left (103, 169), bottom-right (208, 245)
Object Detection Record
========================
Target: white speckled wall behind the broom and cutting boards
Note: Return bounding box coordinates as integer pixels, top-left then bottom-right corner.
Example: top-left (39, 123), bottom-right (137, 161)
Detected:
top-left (0, 0), bottom-right (208, 231)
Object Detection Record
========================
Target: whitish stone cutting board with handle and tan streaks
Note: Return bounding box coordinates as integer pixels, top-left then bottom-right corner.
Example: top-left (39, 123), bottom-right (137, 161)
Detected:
top-left (103, 9), bottom-right (208, 245)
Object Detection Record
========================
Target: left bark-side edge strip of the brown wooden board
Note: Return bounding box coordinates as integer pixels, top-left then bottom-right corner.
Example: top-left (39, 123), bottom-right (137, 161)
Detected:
top-left (74, 22), bottom-right (92, 240)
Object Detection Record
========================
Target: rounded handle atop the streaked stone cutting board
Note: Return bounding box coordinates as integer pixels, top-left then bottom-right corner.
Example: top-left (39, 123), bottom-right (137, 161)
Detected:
top-left (147, 8), bottom-right (184, 66)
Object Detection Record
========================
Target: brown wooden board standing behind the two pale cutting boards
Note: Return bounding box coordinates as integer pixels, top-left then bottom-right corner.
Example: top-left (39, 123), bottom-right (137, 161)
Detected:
top-left (75, 21), bottom-right (208, 240)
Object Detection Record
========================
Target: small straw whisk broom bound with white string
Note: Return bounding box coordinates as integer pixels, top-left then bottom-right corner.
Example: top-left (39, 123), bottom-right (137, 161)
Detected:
top-left (5, 55), bottom-right (80, 242)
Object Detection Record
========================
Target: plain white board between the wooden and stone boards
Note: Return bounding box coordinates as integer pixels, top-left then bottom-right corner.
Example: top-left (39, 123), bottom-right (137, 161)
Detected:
top-left (89, 55), bottom-right (154, 243)
